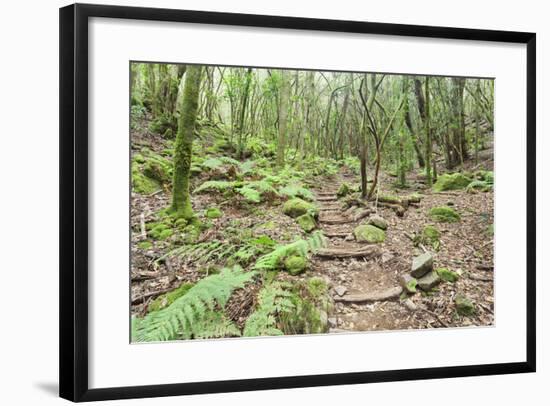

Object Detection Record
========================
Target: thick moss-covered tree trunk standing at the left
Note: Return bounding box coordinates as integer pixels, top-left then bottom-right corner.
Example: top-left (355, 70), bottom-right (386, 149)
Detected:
top-left (170, 65), bottom-right (201, 219)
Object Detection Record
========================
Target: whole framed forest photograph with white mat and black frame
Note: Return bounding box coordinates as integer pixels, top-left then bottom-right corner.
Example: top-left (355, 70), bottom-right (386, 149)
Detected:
top-left (60, 4), bottom-right (536, 401)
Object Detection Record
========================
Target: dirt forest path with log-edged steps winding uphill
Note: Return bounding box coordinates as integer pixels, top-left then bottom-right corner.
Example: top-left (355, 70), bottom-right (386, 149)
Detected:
top-left (313, 174), bottom-right (411, 332)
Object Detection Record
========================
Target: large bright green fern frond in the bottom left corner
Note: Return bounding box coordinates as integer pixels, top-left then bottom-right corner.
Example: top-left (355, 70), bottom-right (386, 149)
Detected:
top-left (132, 267), bottom-right (255, 342)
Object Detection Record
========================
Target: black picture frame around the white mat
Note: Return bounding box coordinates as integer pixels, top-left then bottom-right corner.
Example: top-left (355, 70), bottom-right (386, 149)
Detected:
top-left (59, 4), bottom-right (536, 402)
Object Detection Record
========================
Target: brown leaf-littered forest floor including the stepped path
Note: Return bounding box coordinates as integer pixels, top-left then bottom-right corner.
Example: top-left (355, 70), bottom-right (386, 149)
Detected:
top-left (131, 115), bottom-right (494, 333)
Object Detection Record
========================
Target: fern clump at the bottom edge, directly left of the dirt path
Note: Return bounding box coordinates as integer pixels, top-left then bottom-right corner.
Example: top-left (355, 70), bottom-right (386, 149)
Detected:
top-left (243, 282), bottom-right (294, 337)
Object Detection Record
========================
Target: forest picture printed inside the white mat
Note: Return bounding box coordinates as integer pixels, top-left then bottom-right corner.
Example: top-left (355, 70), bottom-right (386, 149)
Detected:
top-left (129, 62), bottom-right (494, 342)
